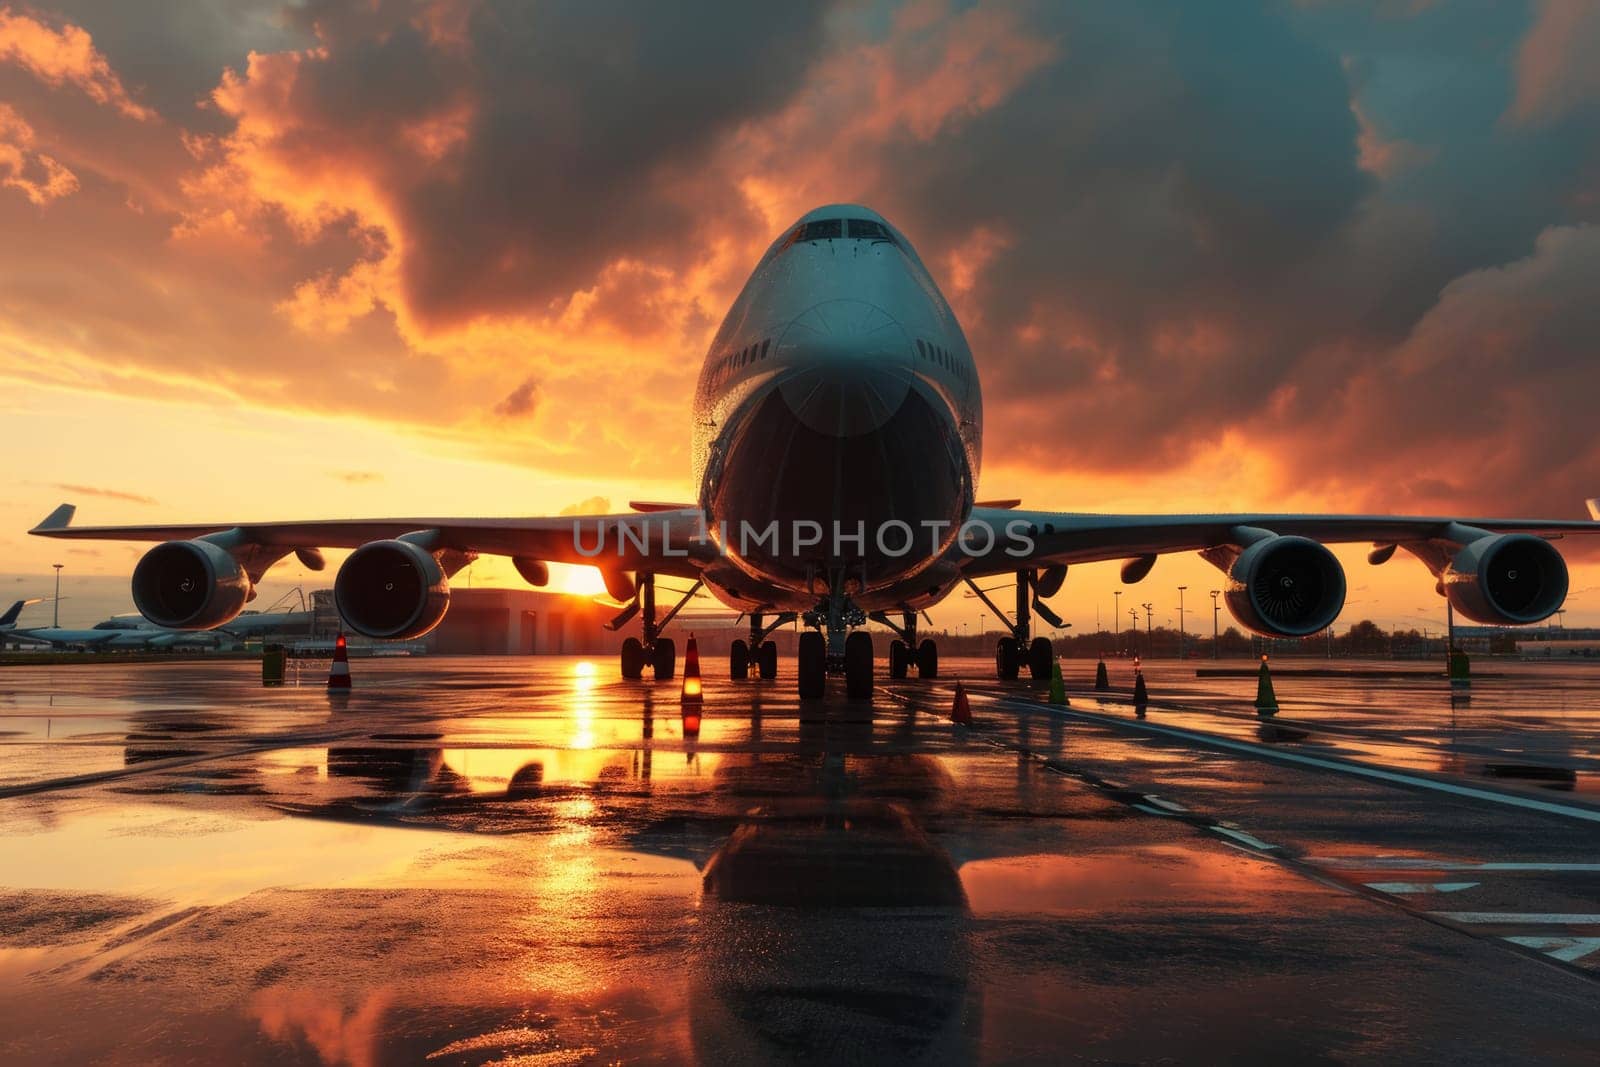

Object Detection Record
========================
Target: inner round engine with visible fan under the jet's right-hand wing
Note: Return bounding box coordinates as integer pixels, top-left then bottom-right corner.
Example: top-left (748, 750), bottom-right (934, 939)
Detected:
top-left (1227, 536), bottom-right (1344, 637)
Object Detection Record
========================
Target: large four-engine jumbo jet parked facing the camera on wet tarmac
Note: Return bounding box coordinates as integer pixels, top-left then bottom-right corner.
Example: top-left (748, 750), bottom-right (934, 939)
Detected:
top-left (30, 203), bottom-right (1600, 699)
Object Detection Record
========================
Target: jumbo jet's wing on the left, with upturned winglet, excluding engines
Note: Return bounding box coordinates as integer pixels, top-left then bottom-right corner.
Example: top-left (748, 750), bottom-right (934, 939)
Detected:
top-left (29, 504), bottom-right (715, 577)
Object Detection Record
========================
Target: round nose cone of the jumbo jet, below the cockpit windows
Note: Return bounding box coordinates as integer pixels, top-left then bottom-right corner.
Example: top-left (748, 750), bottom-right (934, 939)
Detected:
top-left (778, 301), bottom-right (912, 437)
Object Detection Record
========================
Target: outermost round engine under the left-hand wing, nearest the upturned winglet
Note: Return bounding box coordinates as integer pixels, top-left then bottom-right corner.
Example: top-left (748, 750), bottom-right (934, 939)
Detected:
top-left (133, 541), bottom-right (251, 630)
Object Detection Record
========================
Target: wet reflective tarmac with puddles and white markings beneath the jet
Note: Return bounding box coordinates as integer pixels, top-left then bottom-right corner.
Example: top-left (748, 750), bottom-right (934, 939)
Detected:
top-left (0, 657), bottom-right (1600, 1065)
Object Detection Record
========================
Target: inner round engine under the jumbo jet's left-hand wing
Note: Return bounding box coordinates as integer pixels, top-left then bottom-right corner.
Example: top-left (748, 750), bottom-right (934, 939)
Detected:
top-left (333, 541), bottom-right (450, 640)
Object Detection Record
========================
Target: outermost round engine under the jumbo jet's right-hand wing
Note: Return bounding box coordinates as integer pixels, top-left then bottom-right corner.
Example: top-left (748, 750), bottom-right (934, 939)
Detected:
top-left (1438, 534), bottom-right (1566, 625)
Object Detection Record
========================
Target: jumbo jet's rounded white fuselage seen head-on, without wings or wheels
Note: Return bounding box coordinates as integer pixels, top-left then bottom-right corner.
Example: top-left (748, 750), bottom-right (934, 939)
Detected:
top-left (694, 205), bottom-right (982, 611)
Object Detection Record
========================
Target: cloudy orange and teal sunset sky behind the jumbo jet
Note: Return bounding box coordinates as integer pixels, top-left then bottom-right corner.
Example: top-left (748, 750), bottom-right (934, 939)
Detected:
top-left (0, 0), bottom-right (1600, 629)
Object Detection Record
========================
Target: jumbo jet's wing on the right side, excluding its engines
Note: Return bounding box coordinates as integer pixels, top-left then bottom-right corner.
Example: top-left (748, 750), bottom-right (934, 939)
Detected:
top-left (963, 501), bottom-right (1600, 577)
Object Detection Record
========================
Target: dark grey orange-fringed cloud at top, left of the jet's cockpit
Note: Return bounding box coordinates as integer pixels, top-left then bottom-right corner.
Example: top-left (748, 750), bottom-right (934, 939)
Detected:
top-left (237, 0), bottom-right (824, 326)
